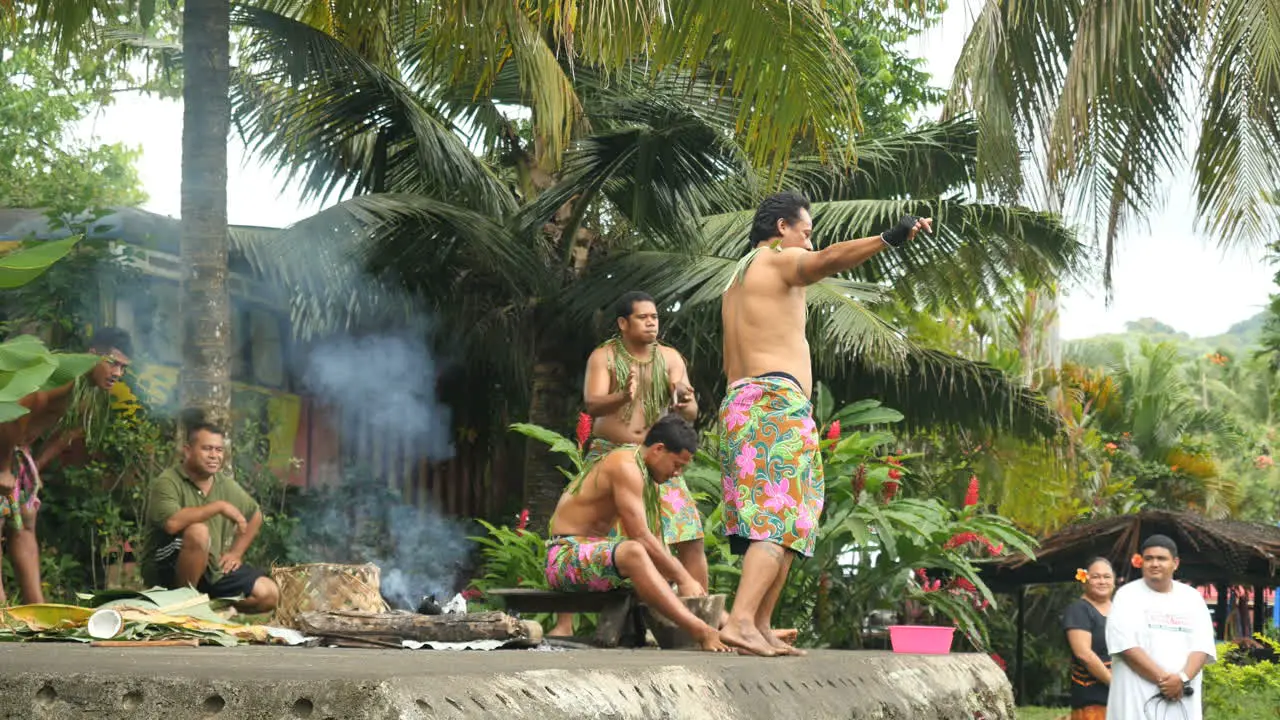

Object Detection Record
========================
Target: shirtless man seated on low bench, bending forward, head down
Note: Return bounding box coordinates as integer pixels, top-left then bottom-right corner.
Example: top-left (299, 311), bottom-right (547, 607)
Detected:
top-left (547, 415), bottom-right (730, 652)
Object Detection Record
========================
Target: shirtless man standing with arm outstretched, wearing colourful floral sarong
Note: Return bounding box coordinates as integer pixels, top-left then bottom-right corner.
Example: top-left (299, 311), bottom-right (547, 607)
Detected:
top-left (719, 192), bottom-right (932, 656)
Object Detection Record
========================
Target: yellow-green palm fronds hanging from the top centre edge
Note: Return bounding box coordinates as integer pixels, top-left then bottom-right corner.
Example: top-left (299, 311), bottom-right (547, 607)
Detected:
top-left (425, 0), bottom-right (858, 172)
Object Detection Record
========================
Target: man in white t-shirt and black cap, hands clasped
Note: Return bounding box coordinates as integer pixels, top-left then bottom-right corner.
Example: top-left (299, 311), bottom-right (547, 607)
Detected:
top-left (1107, 536), bottom-right (1217, 720)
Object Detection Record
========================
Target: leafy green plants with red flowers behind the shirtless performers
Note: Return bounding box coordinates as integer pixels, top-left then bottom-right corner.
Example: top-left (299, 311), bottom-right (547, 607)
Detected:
top-left (483, 384), bottom-right (1033, 648)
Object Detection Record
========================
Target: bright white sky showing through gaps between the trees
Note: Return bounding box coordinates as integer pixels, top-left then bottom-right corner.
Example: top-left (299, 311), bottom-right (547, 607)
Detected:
top-left (78, 0), bottom-right (1275, 340)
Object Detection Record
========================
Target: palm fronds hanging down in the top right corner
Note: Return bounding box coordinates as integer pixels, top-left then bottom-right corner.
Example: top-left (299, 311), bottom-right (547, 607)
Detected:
top-left (947, 0), bottom-right (1280, 286)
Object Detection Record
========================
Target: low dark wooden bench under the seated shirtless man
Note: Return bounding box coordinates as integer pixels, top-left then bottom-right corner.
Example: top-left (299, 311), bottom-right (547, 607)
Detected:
top-left (485, 588), bottom-right (645, 647)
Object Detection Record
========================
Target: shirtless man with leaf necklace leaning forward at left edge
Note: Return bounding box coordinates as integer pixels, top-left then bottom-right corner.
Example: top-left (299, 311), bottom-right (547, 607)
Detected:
top-left (0, 328), bottom-right (132, 603)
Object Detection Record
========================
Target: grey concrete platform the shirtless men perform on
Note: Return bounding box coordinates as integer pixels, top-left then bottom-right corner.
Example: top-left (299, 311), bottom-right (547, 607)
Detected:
top-left (0, 643), bottom-right (1014, 720)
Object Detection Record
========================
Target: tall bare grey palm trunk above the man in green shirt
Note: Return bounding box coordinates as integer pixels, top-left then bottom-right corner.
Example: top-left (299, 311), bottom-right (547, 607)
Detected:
top-left (180, 0), bottom-right (232, 425)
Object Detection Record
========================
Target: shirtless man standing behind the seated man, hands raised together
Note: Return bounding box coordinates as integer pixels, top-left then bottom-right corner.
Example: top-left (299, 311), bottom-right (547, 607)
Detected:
top-left (548, 292), bottom-right (708, 637)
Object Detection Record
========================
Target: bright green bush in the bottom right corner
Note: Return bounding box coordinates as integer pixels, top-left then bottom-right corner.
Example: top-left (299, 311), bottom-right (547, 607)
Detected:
top-left (1204, 633), bottom-right (1280, 720)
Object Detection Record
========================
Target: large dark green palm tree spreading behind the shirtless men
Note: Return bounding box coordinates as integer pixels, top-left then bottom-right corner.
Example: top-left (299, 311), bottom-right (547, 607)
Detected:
top-left (225, 8), bottom-right (1078, 518)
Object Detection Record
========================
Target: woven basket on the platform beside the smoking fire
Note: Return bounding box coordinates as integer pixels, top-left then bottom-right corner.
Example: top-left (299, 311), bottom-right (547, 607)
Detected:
top-left (271, 562), bottom-right (388, 628)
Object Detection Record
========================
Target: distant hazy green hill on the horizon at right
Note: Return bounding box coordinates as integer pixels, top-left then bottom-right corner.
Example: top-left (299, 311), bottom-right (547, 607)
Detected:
top-left (1062, 311), bottom-right (1267, 365)
